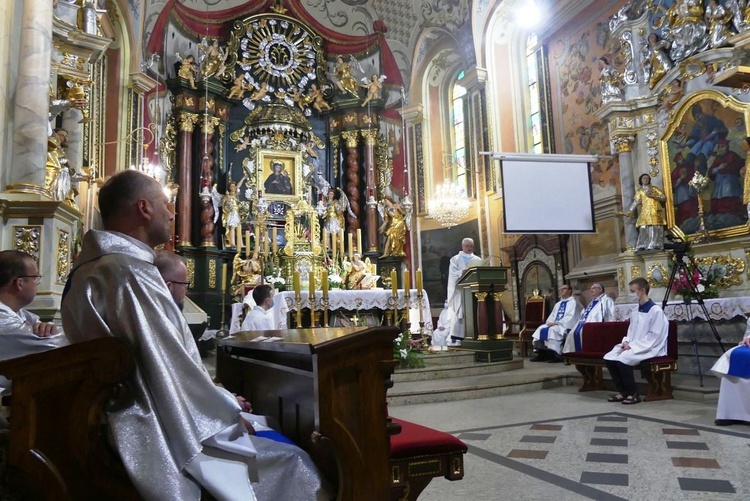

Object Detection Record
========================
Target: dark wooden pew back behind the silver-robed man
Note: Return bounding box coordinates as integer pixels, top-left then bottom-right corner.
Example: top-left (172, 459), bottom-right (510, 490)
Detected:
top-left (0, 338), bottom-right (140, 501)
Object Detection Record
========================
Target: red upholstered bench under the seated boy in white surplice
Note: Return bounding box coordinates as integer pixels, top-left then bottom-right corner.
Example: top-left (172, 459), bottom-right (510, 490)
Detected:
top-left (563, 322), bottom-right (677, 401)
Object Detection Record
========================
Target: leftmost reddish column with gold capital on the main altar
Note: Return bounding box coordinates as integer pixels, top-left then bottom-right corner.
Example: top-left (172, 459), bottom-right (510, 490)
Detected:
top-left (177, 111), bottom-right (198, 246)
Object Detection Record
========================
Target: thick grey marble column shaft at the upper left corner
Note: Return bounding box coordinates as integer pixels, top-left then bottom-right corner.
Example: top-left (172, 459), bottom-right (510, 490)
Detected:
top-left (7, 0), bottom-right (53, 192)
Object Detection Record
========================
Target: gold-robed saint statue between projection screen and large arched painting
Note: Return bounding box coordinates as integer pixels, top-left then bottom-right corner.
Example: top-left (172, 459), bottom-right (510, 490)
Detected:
top-left (625, 174), bottom-right (667, 250)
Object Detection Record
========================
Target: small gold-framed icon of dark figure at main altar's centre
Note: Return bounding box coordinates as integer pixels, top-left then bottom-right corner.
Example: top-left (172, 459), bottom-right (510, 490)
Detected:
top-left (256, 150), bottom-right (304, 203)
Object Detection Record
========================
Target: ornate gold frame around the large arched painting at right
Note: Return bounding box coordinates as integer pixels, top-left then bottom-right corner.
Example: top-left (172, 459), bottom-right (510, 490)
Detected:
top-left (659, 89), bottom-right (750, 240)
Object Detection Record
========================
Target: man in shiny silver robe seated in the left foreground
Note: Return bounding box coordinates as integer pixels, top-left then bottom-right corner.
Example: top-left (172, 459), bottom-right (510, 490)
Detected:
top-left (62, 170), bottom-right (330, 501)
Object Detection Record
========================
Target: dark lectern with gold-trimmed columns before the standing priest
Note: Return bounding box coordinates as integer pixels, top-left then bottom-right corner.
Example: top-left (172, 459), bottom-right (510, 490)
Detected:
top-left (456, 266), bottom-right (513, 362)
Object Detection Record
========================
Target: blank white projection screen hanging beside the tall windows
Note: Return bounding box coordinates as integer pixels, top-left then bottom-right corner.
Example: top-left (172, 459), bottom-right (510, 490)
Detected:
top-left (493, 154), bottom-right (598, 233)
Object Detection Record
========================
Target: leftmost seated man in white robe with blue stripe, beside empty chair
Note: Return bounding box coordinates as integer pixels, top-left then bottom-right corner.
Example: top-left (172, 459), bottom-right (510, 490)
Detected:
top-left (531, 285), bottom-right (583, 362)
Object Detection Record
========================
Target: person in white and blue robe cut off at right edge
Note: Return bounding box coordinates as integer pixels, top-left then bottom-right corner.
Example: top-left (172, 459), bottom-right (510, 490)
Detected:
top-left (711, 319), bottom-right (750, 426)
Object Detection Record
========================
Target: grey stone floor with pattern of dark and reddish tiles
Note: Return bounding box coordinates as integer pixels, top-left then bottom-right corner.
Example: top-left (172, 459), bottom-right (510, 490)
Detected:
top-left (390, 386), bottom-right (750, 501)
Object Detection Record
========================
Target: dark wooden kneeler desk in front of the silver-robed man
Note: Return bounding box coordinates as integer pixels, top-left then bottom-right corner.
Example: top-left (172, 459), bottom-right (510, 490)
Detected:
top-left (217, 327), bottom-right (398, 501)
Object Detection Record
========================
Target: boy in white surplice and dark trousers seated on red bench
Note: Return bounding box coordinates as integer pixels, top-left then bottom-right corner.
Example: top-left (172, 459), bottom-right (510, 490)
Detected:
top-left (604, 278), bottom-right (669, 405)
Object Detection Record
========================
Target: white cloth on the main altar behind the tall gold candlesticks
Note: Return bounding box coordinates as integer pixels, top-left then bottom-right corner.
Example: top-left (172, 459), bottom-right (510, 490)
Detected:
top-left (270, 289), bottom-right (432, 334)
